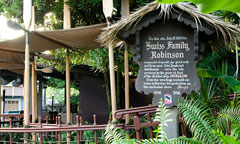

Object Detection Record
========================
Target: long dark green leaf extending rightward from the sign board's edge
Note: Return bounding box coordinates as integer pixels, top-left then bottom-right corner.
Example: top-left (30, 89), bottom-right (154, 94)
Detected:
top-left (197, 68), bottom-right (240, 92)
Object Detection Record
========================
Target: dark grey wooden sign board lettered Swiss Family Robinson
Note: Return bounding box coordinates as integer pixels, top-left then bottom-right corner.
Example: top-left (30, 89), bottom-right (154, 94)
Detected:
top-left (132, 20), bottom-right (200, 106)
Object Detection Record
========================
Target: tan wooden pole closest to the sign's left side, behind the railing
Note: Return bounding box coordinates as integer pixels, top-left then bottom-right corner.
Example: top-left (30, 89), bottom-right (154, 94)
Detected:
top-left (121, 0), bottom-right (130, 139)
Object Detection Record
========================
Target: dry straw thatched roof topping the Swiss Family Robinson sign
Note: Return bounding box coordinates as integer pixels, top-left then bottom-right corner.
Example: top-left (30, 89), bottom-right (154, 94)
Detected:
top-left (98, 2), bottom-right (240, 46)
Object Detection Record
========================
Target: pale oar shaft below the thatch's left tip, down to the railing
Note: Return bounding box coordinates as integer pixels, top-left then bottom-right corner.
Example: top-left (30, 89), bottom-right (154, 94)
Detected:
top-left (108, 45), bottom-right (117, 122)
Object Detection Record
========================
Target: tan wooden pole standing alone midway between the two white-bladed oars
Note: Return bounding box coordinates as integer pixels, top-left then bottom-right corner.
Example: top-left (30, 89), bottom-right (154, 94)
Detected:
top-left (63, 0), bottom-right (71, 143)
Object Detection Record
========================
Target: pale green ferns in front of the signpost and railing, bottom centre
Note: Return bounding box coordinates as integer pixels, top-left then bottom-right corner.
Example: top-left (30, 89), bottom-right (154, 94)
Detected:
top-left (104, 99), bottom-right (202, 144)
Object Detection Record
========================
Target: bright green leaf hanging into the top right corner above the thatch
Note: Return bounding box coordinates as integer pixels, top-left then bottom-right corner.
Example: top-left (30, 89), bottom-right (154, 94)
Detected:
top-left (157, 0), bottom-right (240, 13)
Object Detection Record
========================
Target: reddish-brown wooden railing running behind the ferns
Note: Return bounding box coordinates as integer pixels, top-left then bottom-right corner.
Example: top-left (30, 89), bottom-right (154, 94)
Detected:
top-left (0, 106), bottom-right (161, 144)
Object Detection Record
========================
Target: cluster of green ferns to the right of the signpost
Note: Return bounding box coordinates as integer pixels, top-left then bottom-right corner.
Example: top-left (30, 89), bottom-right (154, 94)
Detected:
top-left (178, 98), bottom-right (240, 144)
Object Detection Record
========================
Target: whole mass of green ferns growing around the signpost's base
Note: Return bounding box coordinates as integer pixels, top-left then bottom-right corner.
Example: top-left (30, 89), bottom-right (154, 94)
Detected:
top-left (104, 98), bottom-right (240, 144)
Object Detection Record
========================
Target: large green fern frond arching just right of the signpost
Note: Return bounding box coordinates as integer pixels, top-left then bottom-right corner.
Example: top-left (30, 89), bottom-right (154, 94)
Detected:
top-left (178, 97), bottom-right (220, 144)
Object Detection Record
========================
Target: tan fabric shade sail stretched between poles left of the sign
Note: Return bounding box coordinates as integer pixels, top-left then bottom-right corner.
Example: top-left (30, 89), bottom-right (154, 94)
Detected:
top-left (0, 24), bottom-right (106, 53)
